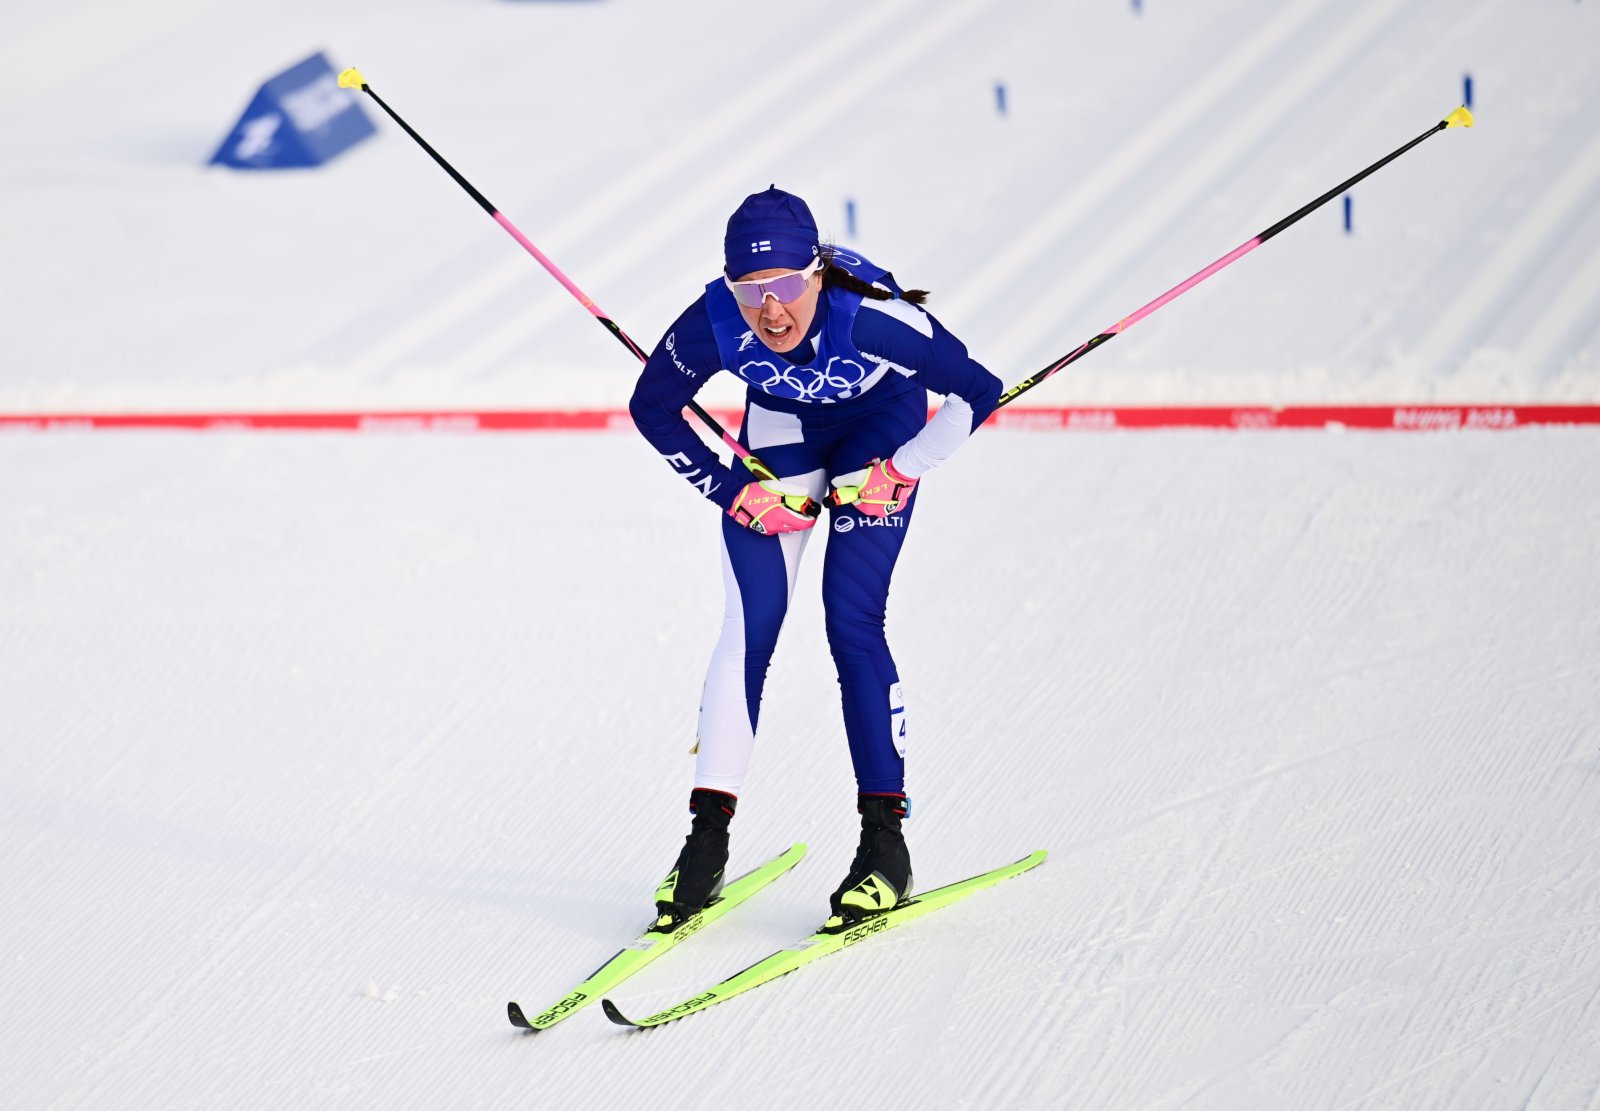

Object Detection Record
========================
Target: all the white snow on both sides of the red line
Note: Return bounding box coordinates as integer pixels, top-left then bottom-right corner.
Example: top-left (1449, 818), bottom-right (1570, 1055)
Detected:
top-left (0, 0), bottom-right (1600, 1109)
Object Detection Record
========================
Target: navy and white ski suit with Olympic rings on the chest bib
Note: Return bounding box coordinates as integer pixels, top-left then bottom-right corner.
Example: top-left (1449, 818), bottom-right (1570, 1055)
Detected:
top-left (629, 253), bottom-right (1002, 794)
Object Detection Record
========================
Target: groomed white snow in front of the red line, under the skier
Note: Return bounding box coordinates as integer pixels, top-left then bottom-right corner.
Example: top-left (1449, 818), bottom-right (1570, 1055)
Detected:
top-left (9, 429), bottom-right (1600, 1108)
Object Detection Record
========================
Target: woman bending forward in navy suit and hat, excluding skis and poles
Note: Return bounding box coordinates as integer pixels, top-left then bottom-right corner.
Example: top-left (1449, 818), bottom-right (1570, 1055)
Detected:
top-left (629, 187), bottom-right (1002, 930)
